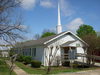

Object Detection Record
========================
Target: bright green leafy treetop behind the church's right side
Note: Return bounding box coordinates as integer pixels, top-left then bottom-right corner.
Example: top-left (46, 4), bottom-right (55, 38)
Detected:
top-left (76, 24), bottom-right (96, 37)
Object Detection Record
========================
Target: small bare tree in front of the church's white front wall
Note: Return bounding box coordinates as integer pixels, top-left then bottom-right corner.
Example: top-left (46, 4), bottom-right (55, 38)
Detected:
top-left (45, 44), bottom-right (60, 74)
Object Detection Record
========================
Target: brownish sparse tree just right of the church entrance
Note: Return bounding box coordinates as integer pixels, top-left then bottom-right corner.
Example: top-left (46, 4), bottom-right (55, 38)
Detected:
top-left (82, 34), bottom-right (99, 65)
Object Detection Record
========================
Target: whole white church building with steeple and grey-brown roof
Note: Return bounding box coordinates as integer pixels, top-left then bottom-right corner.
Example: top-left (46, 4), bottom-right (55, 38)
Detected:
top-left (14, 4), bottom-right (88, 66)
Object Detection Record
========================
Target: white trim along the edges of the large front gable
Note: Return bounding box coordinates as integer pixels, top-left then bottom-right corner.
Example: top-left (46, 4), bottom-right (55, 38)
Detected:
top-left (44, 31), bottom-right (89, 46)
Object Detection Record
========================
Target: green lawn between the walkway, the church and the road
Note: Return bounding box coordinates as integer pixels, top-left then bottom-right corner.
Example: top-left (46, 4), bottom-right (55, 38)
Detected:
top-left (15, 62), bottom-right (99, 74)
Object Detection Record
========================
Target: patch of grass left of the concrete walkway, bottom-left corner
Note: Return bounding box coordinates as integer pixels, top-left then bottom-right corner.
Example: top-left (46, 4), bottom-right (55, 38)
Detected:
top-left (0, 59), bottom-right (16, 75)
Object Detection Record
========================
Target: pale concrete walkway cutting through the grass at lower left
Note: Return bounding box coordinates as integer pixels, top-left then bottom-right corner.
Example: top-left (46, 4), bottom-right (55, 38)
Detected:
top-left (6, 61), bottom-right (29, 75)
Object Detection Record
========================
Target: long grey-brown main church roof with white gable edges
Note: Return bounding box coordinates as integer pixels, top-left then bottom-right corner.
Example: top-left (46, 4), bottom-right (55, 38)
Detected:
top-left (15, 31), bottom-right (86, 47)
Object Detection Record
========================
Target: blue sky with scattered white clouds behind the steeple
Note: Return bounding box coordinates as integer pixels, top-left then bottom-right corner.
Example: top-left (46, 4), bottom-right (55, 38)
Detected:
top-left (17, 0), bottom-right (100, 39)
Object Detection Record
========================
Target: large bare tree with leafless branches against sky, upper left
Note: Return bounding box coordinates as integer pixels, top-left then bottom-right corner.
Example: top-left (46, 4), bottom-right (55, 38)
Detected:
top-left (0, 0), bottom-right (25, 75)
